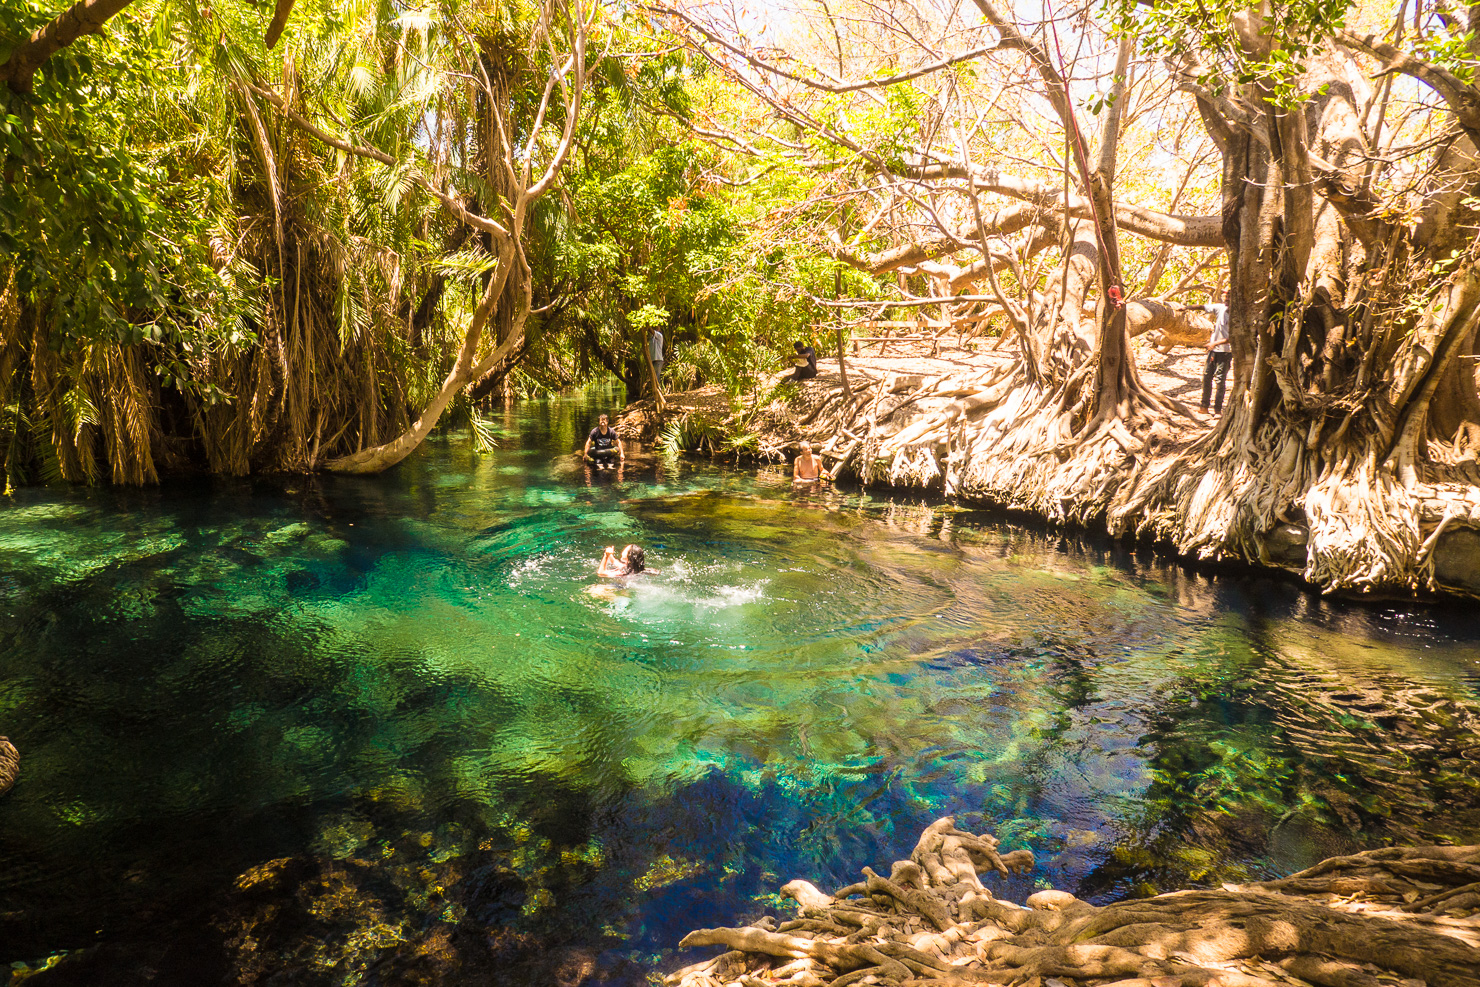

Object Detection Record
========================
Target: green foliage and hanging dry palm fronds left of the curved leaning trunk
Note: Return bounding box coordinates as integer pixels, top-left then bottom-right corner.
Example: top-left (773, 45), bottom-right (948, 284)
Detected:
top-left (0, 0), bottom-right (467, 482)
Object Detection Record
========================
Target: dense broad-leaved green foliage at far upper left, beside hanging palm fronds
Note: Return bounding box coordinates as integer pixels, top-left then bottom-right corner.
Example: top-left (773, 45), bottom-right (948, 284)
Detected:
top-left (0, 0), bottom-right (252, 363)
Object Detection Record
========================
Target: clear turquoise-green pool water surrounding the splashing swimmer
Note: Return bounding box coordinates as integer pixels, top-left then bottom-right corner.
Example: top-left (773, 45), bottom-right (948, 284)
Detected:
top-left (0, 390), bottom-right (1480, 984)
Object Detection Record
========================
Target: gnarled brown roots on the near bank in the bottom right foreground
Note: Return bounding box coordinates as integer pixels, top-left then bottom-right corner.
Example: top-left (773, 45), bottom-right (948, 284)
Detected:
top-left (663, 817), bottom-right (1480, 987)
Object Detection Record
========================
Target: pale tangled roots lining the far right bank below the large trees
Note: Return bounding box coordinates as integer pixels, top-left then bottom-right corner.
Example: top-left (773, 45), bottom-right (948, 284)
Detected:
top-left (683, 361), bottom-right (1480, 598)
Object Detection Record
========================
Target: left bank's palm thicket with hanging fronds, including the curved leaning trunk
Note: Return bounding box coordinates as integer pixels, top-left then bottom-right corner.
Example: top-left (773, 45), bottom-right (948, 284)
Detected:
top-left (0, 0), bottom-right (620, 485)
